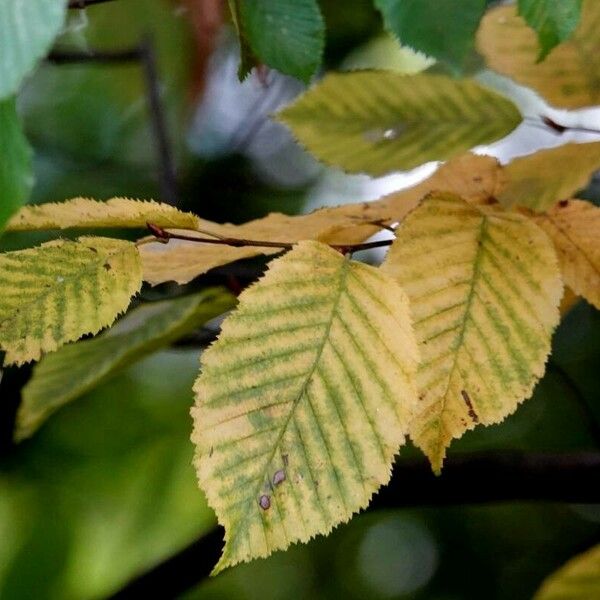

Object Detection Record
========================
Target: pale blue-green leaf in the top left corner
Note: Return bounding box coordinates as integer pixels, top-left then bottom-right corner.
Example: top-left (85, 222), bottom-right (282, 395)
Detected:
top-left (0, 0), bottom-right (67, 99)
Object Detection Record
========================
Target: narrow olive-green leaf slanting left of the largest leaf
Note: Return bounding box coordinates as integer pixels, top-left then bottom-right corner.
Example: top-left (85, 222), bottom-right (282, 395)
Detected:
top-left (15, 289), bottom-right (235, 441)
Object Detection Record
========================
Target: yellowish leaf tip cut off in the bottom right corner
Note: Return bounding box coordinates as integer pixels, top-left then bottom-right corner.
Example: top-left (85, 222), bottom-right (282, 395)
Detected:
top-left (534, 545), bottom-right (600, 600)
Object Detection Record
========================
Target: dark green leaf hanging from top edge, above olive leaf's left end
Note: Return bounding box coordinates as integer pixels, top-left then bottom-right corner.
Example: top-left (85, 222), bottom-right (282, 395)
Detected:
top-left (234, 0), bottom-right (325, 83)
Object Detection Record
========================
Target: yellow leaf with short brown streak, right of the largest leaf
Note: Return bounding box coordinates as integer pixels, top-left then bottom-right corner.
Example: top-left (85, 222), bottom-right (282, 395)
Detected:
top-left (382, 193), bottom-right (562, 472)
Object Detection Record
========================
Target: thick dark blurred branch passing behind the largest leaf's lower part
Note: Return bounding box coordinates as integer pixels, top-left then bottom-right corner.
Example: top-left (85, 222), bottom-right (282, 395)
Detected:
top-left (113, 452), bottom-right (600, 599)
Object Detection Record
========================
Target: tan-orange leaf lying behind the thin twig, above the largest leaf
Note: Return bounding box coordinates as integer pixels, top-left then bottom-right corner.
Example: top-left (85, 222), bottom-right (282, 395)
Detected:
top-left (140, 203), bottom-right (381, 285)
